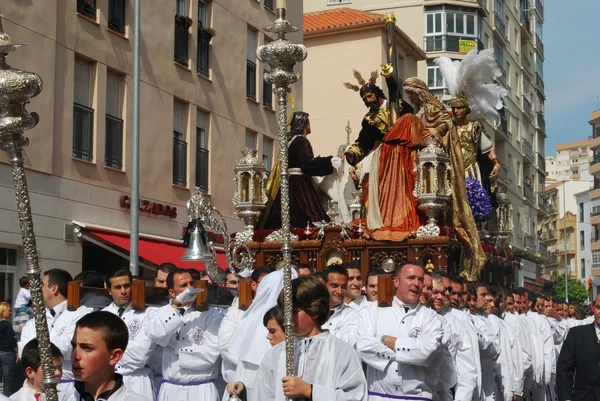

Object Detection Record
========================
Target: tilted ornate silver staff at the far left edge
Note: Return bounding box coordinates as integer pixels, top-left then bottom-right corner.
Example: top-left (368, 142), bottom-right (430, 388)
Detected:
top-left (0, 15), bottom-right (58, 401)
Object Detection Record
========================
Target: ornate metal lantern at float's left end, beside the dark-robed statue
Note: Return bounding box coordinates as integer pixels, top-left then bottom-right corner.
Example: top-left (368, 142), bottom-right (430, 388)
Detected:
top-left (233, 148), bottom-right (267, 241)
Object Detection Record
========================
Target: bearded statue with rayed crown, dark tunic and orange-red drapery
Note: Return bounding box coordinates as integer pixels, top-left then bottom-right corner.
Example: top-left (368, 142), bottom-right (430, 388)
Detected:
top-left (344, 64), bottom-right (425, 241)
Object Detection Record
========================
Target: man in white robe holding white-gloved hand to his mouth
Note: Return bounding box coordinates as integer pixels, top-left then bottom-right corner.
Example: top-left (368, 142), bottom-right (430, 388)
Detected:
top-left (149, 269), bottom-right (222, 401)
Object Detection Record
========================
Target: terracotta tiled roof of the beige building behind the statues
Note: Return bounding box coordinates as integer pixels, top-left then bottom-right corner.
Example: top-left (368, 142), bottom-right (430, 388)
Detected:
top-left (304, 7), bottom-right (385, 33)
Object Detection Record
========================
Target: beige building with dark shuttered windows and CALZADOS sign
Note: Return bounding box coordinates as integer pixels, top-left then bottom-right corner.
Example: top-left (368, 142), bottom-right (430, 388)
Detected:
top-left (0, 0), bottom-right (302, 298)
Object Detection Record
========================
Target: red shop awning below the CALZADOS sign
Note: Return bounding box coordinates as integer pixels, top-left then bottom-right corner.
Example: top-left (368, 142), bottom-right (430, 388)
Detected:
top-left (85, 227), bottom-right (227, 271)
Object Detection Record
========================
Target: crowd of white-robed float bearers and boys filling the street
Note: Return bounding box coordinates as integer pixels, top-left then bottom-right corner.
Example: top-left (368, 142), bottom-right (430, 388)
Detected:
top-left (0, 263), bottom-right (600, 401)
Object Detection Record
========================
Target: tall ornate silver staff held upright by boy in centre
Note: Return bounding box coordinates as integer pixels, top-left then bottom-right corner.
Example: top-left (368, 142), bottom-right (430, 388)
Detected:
top-left (256, 0), bottom-right (307, 382)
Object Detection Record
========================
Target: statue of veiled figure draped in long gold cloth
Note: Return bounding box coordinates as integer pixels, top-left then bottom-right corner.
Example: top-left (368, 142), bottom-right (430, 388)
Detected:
top-left (404, 77), bottom-right (486, 281)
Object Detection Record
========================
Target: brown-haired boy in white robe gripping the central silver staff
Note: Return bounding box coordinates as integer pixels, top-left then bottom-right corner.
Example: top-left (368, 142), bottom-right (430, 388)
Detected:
top-left (252, 276), bottom-right (367, 401)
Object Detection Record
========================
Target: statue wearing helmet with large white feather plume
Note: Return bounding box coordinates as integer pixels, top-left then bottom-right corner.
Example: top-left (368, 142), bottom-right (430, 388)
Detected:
top-left (435, 49), bottom-right (508, 206)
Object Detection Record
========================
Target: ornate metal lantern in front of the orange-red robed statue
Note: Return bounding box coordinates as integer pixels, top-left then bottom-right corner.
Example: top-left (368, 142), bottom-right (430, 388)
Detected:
top-left (413, 135), bottom-right (452, 237)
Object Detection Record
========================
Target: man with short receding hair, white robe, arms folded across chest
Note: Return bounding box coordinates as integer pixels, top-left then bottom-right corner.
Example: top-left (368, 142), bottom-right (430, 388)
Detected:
top-left (356, 263), bottom-right (446, 401)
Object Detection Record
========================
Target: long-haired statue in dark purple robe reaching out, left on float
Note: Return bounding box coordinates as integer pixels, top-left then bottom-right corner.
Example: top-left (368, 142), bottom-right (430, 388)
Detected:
top-left (259, 112), bottom-right (340, 229)
